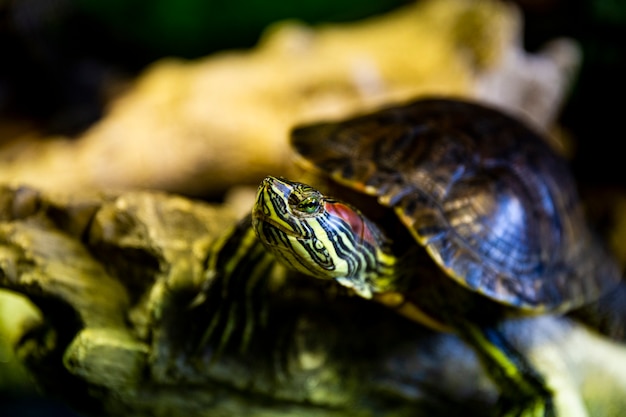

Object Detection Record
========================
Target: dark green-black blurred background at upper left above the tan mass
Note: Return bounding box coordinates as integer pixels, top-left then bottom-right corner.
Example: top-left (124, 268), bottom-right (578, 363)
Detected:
top-left (0, 0), bottom-right (406, 135)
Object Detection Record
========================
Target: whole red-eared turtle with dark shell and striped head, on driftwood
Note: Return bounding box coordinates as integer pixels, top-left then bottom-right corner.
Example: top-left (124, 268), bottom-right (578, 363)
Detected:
top-left (201, 97), bottom-right (620, 416)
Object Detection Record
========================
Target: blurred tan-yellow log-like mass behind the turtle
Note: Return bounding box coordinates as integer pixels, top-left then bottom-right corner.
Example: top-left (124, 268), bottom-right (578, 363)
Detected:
top-left (0, 0), bottom-right (579, 194)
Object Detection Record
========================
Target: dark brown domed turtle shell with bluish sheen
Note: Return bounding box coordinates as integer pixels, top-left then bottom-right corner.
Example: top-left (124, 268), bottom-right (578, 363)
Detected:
top-left (292, 98), bottom-right (619, 310)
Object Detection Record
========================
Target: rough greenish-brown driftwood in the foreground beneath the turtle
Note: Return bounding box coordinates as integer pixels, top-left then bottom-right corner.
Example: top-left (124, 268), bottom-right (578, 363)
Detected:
top-left (0, 187), bottom-right (626, 417)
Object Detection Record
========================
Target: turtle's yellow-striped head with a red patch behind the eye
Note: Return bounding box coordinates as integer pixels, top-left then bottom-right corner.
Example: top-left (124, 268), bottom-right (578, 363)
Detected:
top-left (252, 177), bottom-right (395, 298)
